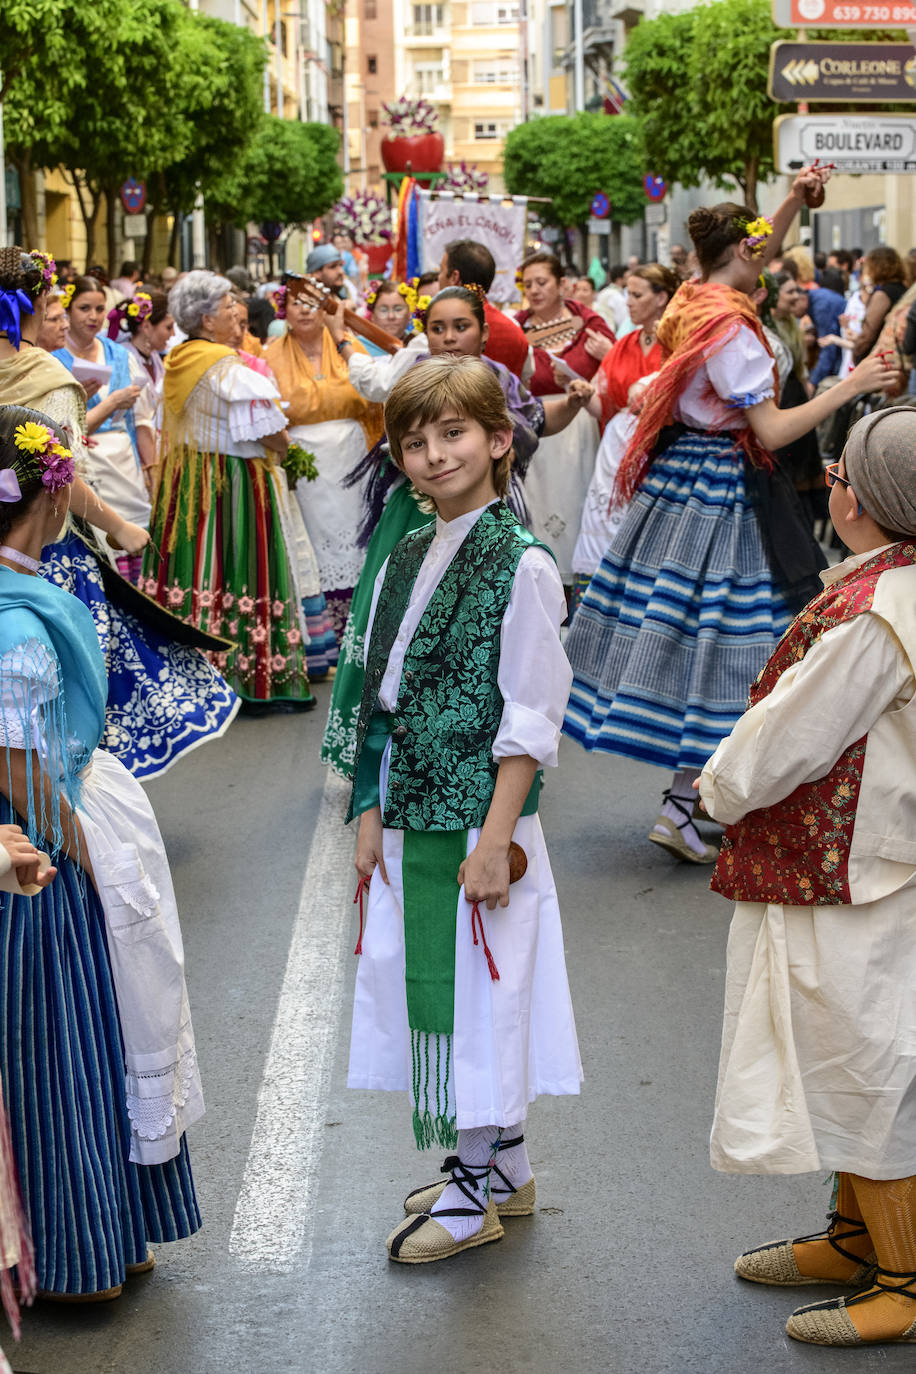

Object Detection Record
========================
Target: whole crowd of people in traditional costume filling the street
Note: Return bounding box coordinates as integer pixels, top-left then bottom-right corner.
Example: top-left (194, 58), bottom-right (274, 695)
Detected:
top-left (0, 158), bottom-right (916, 1344)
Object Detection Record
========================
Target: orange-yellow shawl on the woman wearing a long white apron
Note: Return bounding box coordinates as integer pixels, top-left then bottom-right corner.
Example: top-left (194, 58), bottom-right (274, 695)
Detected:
top-left (265, 330), bottom-right (385, 448)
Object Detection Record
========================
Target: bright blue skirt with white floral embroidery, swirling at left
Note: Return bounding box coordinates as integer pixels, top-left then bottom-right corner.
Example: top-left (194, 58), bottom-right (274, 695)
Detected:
top-left (41, 533), bottom-right (239, 782)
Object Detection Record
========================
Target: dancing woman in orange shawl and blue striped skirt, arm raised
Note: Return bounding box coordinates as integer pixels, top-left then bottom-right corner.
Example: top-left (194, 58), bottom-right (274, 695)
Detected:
top-left (563, 166), bottom-right (894, 863)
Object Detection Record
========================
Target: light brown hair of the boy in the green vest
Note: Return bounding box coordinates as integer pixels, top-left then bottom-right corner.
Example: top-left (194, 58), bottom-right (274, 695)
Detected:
top-left (385, 356), bottom-right (512, 510)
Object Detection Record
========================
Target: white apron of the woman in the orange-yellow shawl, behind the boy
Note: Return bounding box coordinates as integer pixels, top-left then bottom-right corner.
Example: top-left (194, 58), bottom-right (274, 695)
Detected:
top-left (290, 420), bottom-right (368, 592)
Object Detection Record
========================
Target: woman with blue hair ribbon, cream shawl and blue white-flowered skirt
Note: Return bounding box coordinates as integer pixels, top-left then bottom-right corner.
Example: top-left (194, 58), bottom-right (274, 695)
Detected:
top-left (0, 249), bottom-right (239, 779)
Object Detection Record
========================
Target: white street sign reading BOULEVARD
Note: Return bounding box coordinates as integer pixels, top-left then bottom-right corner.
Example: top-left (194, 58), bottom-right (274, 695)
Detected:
top-left (773, 114), bottom-right (916, 173)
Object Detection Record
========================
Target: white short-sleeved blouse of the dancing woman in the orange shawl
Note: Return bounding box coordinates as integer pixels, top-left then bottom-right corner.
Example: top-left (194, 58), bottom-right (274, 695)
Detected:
top-left (674, 324), bottom-right (776, 430)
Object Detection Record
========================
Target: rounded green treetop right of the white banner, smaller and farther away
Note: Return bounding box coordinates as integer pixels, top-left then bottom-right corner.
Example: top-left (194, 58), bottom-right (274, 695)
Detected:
top-left (503, 113), bottom-right (645, 228)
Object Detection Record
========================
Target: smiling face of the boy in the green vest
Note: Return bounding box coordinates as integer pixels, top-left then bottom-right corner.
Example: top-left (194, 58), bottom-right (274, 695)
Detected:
top-left (401, 414), bottom-right (512, 521)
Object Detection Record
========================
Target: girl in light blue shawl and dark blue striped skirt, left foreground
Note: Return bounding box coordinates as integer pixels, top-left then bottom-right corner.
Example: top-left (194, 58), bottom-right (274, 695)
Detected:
top-left (0, 405), bottom-right (203, 1303)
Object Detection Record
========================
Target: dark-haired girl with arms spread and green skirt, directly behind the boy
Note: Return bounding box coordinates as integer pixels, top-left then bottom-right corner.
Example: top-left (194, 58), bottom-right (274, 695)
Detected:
top-left (321, 286), bottom-right (592, 778)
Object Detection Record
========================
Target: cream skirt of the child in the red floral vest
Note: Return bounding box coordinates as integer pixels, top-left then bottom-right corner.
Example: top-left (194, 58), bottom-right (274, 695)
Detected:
top-left (710, 879), bottom-right (916, 1179)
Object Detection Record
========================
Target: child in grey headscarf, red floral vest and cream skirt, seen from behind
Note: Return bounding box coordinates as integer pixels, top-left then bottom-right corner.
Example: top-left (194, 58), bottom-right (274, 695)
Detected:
top-left (699, 407), bottom-right (916, 1345)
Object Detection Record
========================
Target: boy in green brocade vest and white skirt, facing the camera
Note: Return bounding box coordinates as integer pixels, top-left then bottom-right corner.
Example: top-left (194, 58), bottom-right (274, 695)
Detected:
top-left (347, 357), bottom-right (581, 1264)
